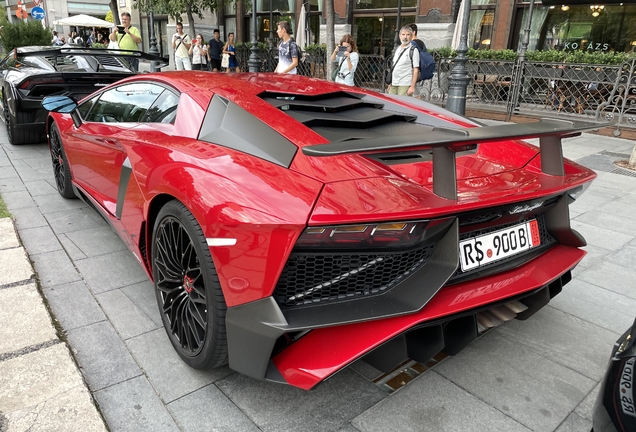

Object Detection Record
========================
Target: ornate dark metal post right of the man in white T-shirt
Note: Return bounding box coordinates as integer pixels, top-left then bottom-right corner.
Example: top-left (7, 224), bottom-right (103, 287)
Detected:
top-left (446, 0), bottom-right (471, 115)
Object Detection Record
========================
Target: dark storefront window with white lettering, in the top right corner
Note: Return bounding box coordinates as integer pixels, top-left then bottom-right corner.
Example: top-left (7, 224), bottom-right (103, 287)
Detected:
top-left (517, 5), bottom-right (636, 52)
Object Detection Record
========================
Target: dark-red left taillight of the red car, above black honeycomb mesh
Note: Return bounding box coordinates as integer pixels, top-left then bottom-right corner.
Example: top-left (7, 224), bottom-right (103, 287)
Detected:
top-left (294, 221), bottom-right (428, 250)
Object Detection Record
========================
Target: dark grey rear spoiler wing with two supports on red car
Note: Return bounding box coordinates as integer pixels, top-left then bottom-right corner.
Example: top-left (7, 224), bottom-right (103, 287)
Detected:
top-left (302, 118), bottom-right (609, 200)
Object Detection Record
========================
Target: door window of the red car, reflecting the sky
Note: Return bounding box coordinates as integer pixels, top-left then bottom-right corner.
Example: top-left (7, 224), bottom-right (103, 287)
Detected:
top-left (86, 83), bottom-right (164, 123)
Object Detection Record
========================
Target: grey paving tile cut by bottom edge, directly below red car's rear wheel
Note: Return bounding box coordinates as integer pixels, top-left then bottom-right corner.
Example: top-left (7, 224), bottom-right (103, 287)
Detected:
top-left (168, 384), bottom-right (260, 432)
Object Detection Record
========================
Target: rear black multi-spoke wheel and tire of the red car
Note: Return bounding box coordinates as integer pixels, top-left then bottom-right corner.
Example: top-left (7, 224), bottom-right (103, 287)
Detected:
top-left (151, 200), bottom-right (228, 369)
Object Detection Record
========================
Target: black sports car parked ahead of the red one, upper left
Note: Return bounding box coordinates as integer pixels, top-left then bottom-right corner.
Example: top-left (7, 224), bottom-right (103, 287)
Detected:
top-left (0, 45), bottom-right (163, 144)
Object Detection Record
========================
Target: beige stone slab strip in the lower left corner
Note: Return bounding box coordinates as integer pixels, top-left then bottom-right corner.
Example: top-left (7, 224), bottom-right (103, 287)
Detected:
top-left (0, 218), bottom-right (106, 432)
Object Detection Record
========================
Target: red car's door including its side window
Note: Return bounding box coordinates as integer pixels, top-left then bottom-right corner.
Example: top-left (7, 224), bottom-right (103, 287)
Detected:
top-left (65, 82), bottom-right (165, 215)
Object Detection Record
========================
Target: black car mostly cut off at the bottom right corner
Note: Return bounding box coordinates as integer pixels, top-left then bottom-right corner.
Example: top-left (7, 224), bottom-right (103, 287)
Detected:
top-left (592, 321), bottom-right (636, 432)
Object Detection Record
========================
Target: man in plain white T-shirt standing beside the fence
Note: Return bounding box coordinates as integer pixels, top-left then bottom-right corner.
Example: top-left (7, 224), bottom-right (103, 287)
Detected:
top-left (389, 25), bottom-right (420, 96)
